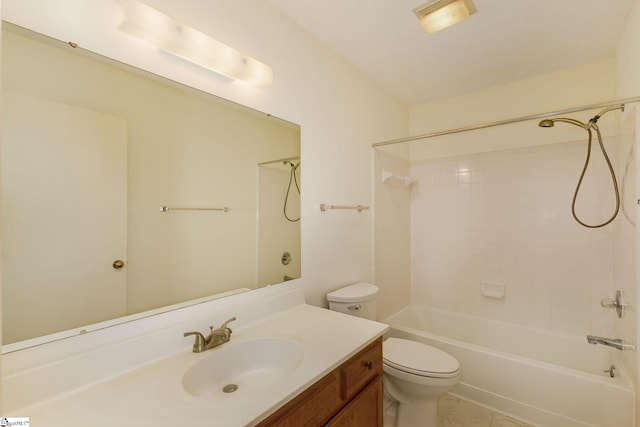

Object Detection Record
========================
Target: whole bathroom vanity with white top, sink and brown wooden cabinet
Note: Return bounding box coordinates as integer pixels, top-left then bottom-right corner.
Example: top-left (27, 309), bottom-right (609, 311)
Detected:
top-left (2, 285), bottom-right (388, 427)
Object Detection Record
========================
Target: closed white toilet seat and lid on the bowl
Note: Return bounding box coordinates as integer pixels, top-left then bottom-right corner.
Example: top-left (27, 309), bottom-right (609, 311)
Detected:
top-left (382, 338), bottom-right (460, 378)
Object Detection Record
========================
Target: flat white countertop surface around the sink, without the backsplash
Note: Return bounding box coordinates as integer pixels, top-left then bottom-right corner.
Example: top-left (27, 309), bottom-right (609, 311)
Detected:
top-left (10, 304), bottom-right (388, 427)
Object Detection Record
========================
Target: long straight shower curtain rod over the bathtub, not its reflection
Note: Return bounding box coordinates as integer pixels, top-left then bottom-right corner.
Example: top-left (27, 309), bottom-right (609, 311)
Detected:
top-left (371, 96), bottom-right (640, 148)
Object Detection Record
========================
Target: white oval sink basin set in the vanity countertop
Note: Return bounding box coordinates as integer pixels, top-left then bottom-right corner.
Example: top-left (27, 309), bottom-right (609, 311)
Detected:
top-left (182, 338), bottom-right (304, 399)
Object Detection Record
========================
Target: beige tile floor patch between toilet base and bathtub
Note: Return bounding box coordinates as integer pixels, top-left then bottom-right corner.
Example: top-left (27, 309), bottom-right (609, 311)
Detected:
top-left (438, 394), bottom-right (533, 427)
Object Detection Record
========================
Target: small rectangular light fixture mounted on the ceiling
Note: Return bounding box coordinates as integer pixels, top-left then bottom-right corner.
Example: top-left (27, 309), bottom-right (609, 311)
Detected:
top-left (413, 0), bottom-right (476, 34)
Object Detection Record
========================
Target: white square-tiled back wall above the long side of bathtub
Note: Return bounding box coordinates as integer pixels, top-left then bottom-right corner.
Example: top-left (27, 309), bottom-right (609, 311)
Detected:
top-left (411, 137), bottom-right (635, 336)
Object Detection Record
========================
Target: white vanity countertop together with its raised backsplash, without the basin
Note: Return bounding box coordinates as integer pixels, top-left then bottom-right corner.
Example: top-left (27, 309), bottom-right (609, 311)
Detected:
top-left (3, 285), bottom-right (387, 427)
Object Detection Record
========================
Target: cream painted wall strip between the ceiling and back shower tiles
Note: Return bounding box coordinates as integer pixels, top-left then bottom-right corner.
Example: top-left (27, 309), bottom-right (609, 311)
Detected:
top-left (410, 59), bottom-right (616, 160)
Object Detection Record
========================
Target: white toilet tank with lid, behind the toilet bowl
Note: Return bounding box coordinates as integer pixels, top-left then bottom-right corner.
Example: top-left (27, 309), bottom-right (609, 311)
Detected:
top-left (327, 282), bottom-right (378, 320)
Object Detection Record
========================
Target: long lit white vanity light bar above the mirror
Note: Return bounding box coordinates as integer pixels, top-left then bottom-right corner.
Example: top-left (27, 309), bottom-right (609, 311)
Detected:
top-left (118, 0), bottom-right (273, 88)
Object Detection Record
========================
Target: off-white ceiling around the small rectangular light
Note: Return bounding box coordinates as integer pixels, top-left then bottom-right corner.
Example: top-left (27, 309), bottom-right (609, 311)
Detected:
top-left (269, 0), bottom-right (638, 106)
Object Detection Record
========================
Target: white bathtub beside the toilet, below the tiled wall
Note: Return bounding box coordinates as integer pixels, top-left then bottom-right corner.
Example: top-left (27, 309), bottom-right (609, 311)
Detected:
top-left (386, 306), bottom-right (635, 427)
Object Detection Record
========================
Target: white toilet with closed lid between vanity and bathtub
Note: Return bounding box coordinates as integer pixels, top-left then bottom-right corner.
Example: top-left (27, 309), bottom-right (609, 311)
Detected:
top-left (327, 283), bottom-right (461, 427)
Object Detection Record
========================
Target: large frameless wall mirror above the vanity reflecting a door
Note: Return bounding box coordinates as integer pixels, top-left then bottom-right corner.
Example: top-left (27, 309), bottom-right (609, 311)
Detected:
top-left (0, 23), bottom-right (302, 351)
